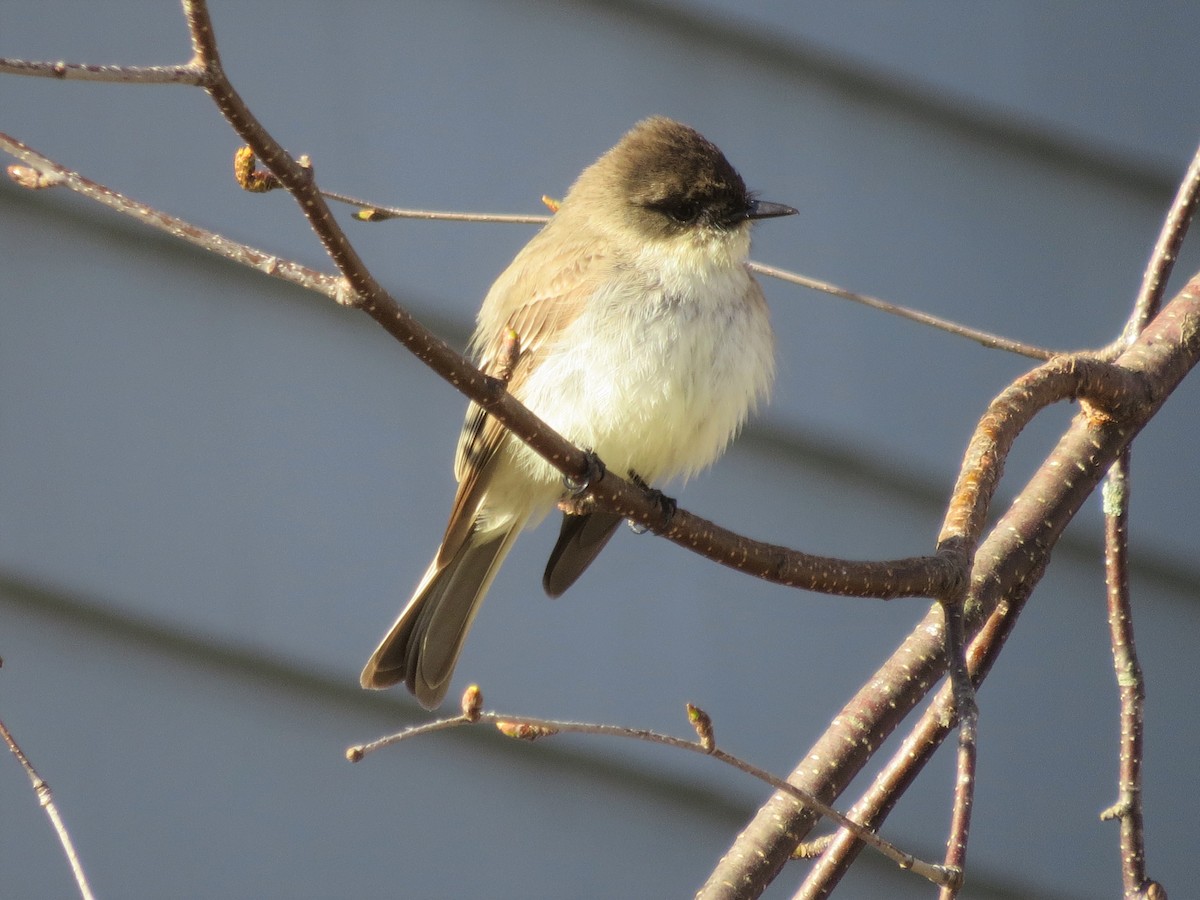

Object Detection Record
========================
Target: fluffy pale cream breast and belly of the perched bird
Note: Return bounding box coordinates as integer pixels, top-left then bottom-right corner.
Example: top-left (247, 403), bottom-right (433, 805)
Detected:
top-left (511, 265), bottom-right (774, 482)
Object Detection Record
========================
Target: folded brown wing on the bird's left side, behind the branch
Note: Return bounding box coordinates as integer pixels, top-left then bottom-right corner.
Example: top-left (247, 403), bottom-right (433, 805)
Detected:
top-left (438, 240), bottom-right (607, 560)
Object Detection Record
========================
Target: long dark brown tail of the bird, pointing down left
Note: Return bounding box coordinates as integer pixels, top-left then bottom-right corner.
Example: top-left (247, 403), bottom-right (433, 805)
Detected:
top-left (359, 518), bottom-right (524, 709)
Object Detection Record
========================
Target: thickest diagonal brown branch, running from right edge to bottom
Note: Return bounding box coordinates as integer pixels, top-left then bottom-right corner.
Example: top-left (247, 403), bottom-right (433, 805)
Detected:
top-left (697, 276), bottom-right (1200, 900)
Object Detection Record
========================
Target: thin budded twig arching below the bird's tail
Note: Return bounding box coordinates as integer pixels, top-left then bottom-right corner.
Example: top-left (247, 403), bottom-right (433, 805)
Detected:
top-left (346, 685), bottom-right (961, 887)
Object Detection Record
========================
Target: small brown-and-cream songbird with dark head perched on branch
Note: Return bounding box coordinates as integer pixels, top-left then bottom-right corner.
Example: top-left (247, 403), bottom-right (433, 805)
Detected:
top-left (361, 118), bottom-right (796, 709)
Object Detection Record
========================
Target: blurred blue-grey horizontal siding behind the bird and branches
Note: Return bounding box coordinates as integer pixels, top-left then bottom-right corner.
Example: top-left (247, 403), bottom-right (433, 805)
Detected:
top-left (0, 0), bottom-right (1200, 899)
